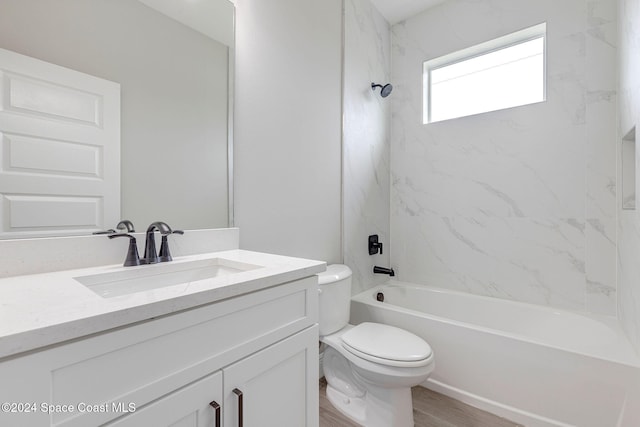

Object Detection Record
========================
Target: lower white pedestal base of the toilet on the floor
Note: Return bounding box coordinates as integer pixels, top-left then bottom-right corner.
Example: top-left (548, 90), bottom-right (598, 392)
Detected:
top-left (327, 384), bottom-right (414, 427)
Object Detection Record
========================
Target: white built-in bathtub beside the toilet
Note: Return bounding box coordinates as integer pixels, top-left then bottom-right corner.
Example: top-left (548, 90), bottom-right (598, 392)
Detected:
top-left (351, 281), bottom-right (640, 427)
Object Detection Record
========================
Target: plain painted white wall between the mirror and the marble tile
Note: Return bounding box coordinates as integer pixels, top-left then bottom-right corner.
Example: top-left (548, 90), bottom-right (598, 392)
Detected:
top-left (234, 0), bottom-right (342, 263)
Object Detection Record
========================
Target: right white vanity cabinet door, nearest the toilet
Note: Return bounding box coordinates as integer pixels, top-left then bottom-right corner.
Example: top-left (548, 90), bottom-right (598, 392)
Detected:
top-left (223, 326), bottom-right (318, 427)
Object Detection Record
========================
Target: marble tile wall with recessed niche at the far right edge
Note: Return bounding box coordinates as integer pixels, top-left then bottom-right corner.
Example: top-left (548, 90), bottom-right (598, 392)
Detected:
top-left (618, 0), bottom-right (640, 351)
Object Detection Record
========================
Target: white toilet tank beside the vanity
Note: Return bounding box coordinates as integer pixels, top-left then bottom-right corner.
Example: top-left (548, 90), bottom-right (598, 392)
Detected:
top-left (318, 264), bottom-right (351, 336)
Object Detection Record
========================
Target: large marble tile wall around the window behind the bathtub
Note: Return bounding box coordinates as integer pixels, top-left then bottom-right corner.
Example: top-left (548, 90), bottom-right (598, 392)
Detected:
top-left (390, 0), bottom-right (617, 315)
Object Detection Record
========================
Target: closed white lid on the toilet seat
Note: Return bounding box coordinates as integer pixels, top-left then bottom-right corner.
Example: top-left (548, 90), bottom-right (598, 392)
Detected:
top-left (342, 322), bottom-right (431, 362)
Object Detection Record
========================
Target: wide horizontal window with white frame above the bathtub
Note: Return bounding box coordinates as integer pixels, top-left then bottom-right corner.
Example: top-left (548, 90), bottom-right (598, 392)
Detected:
top-left (423, 24), bottom-right (546, 124)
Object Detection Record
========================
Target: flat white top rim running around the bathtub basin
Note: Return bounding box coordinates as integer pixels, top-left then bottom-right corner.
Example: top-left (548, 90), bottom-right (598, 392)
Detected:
top-left (351, 279), bottom-right (640, 368)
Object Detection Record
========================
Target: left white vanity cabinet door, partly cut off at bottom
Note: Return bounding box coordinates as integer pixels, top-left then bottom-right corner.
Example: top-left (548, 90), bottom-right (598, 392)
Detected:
top-left (106, 372), bottom-right (222, 427)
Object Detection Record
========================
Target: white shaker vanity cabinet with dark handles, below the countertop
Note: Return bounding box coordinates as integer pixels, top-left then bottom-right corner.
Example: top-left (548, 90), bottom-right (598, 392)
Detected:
top-left (0, 276), bottom-right (318, 427)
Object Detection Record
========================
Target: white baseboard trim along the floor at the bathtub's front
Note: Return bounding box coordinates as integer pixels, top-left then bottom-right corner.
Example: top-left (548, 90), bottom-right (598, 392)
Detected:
top-left (420, 378), bottom-right (575, 427)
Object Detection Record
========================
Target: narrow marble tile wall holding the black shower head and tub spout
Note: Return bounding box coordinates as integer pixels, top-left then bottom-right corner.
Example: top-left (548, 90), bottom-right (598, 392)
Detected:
top-left (343, 0), bottom-right (394, 294)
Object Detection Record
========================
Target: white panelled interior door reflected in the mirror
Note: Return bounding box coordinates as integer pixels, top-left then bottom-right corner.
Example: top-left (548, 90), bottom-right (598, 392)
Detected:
top-left (0, 49), bottom-right (120, 238)
